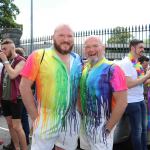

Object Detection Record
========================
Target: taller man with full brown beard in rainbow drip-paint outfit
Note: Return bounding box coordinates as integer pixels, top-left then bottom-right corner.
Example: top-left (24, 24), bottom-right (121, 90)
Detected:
top-left (20, 24), bottom-right (82, 150)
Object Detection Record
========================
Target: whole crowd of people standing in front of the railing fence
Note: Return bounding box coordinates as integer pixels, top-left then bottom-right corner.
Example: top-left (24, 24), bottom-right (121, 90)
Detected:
top-left (0, 24), bottom-right (150, 150)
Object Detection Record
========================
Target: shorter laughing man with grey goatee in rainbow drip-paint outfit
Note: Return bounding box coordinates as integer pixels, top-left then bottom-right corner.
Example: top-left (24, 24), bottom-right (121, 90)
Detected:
top-left (80, 36), bottom-right (127, 150)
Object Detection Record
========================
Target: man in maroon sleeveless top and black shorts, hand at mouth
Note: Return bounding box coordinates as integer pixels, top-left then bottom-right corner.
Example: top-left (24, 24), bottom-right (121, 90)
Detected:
top-left (0, 39), bottom-right (27, 150)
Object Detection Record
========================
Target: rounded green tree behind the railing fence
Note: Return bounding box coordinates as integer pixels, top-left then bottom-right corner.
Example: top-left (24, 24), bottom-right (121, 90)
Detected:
top-left (107, 27), bottom-right (133, 44)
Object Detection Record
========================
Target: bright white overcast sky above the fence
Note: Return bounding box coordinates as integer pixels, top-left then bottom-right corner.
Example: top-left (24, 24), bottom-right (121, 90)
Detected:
top-left (14, 0), bottom-right (150, 39)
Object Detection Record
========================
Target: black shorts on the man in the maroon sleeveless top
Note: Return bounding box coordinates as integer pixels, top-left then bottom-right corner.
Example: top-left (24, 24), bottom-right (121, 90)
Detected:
top-left (1, 99), bottom-right (23, 119)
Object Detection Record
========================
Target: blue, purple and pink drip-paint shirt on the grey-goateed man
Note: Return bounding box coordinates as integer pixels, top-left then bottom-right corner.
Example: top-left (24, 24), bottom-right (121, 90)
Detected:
top-left (80, 58), bottom-right (127, 141)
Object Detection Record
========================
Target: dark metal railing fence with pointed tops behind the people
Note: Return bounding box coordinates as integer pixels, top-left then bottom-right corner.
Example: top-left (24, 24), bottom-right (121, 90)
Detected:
top-left (21, 24), bottom-right (150, 60)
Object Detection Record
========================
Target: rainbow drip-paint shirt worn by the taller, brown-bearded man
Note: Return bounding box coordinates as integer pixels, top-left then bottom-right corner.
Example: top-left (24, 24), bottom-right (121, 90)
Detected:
top-left (21, 47), bottom-right (82, 136)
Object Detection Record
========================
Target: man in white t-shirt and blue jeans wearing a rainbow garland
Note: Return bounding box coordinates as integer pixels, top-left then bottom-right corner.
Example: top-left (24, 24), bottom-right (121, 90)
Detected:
top-left (120, 39), bottom-right (150, 150)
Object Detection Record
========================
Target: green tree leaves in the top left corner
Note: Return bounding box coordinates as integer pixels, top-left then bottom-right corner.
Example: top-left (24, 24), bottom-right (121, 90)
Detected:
top-left (0, 0), bottom-right (22, 29)
